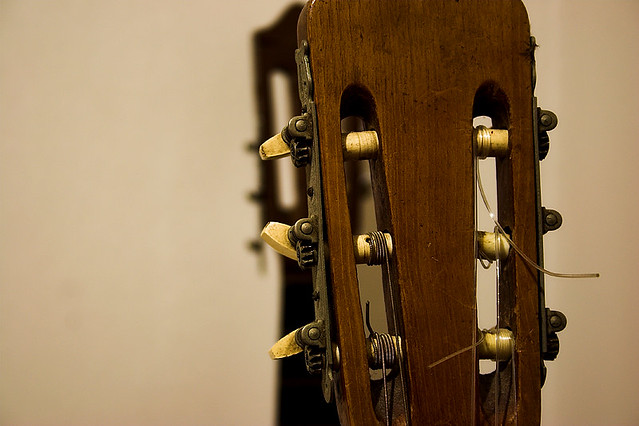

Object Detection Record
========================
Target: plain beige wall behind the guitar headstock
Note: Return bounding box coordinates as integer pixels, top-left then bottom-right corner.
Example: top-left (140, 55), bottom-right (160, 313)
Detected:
top-left (0, 0), bottom-right (639, 425)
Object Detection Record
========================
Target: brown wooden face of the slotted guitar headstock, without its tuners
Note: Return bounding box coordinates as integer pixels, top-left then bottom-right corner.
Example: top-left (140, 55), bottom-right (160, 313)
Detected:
top-left (298, 0), bottom-right (540, 425)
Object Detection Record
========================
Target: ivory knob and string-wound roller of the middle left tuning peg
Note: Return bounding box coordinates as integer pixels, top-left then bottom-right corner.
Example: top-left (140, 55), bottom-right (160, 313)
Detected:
top-left (260, 222), bottom-right (393, 265)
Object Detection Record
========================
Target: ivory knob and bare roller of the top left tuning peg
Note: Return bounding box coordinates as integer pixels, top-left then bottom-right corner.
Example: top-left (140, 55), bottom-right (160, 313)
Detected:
top-left (259, 130), bottom-right (379, 161)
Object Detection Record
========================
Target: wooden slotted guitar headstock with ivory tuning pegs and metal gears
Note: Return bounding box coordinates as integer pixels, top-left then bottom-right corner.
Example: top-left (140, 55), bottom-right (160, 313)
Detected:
top-left (254, 0), bottom-right (596, 425)
